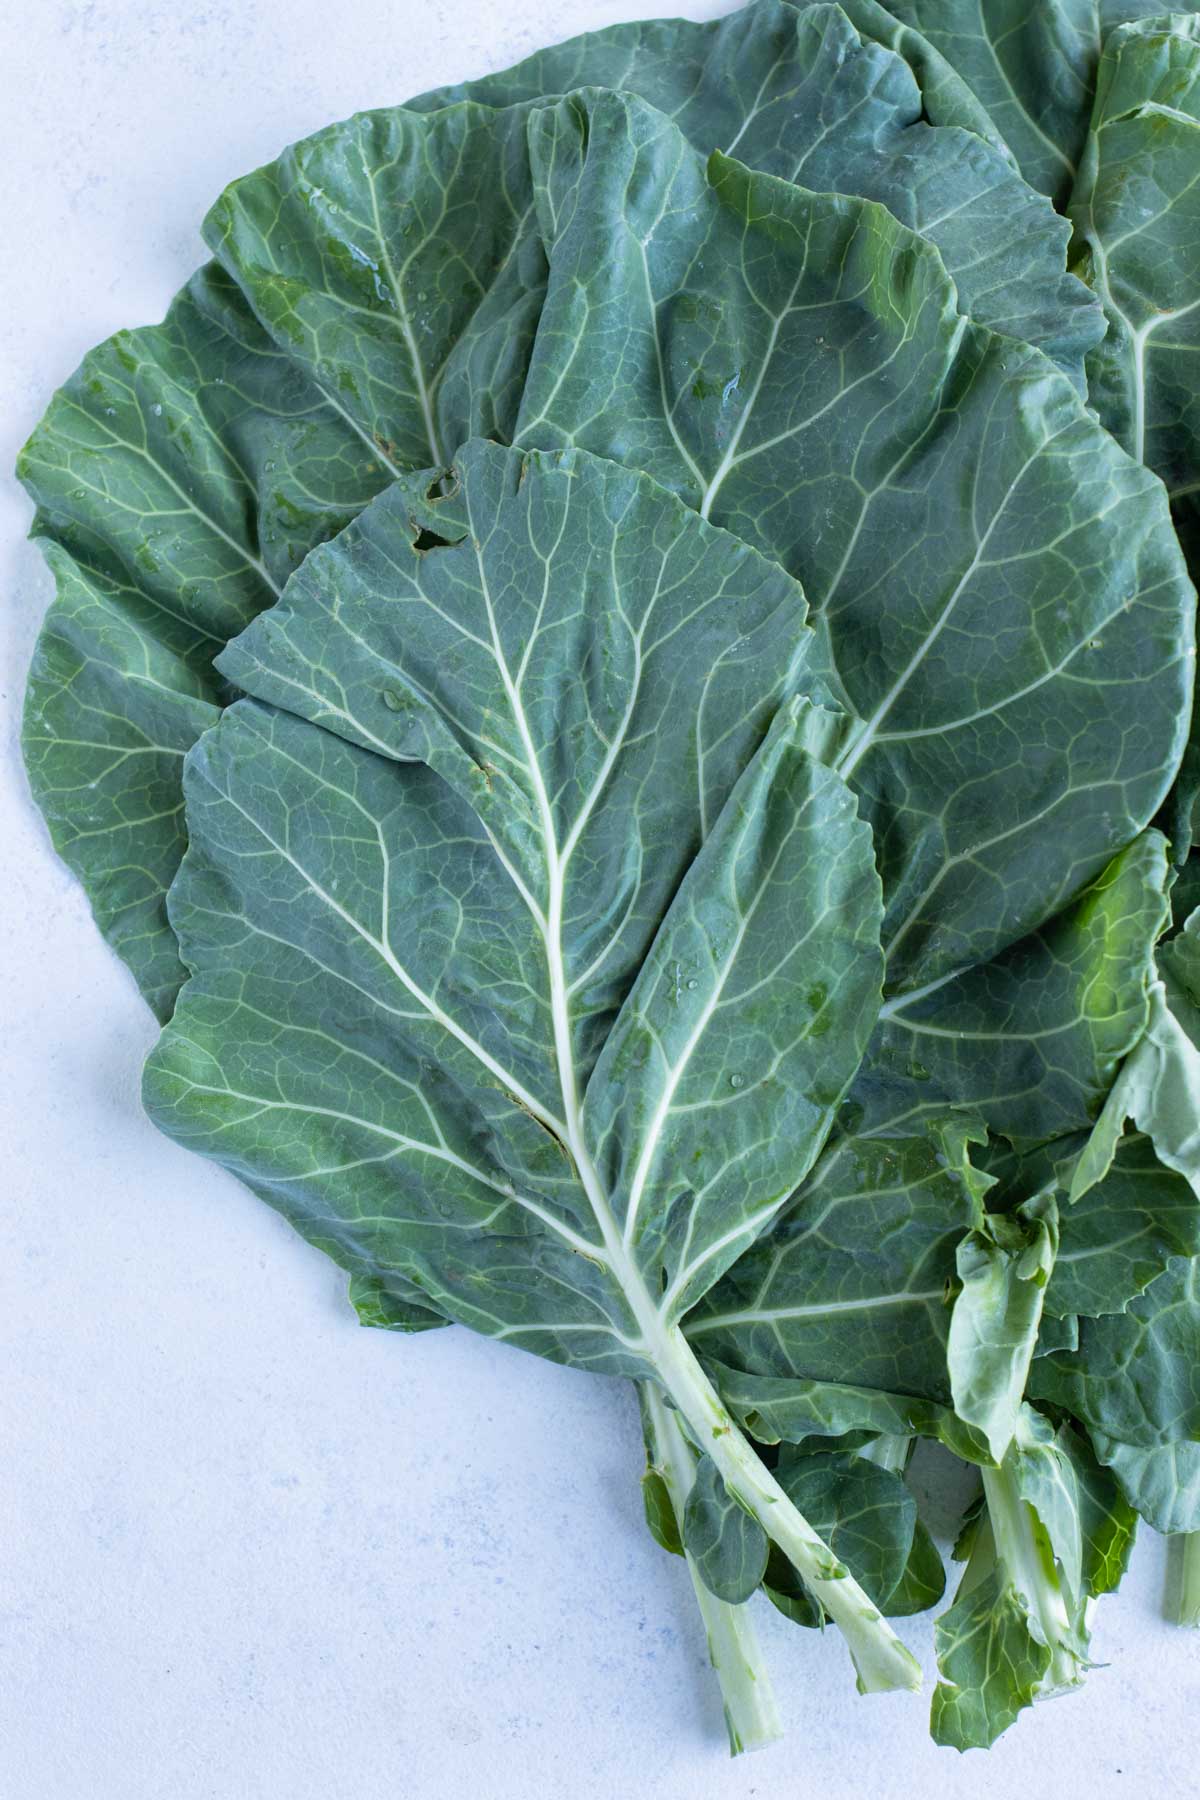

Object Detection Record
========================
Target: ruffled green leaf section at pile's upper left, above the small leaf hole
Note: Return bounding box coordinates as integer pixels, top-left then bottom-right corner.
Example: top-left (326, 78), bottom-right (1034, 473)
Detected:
top-left (203, 103), bottom-right (545, 470)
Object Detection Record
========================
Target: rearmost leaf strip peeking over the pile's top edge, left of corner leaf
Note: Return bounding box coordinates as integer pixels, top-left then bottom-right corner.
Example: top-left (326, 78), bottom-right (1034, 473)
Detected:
top-left (414, 0), bottom-right (1101, 383)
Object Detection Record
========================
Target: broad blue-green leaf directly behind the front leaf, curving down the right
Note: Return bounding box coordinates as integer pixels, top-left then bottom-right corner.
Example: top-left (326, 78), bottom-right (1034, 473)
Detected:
top-left (518, 95), bottom-right (1193, 988)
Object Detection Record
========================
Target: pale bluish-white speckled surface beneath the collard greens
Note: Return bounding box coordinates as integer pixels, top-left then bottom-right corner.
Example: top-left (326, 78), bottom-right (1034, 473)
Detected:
top-left (0, 0), bottom-right (1200, 1800)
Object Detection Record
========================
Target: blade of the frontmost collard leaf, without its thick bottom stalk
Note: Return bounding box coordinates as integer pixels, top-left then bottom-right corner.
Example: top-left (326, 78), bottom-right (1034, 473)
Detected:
top-left (151, 445), bottom-right (878, 1361)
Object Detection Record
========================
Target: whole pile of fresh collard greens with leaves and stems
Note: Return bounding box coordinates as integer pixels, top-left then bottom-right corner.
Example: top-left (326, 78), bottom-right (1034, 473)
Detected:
top-left (22, 0), bottom-right (1200, 1750)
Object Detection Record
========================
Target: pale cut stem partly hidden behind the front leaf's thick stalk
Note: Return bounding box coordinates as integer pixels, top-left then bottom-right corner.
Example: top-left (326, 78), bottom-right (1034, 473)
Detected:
top-left (640, 1381), bottom-right (783, 1757)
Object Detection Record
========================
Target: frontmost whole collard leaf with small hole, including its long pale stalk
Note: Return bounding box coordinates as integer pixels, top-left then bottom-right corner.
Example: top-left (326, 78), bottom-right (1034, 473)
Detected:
top-left (146, 443), bottom-right (914, 1687)
